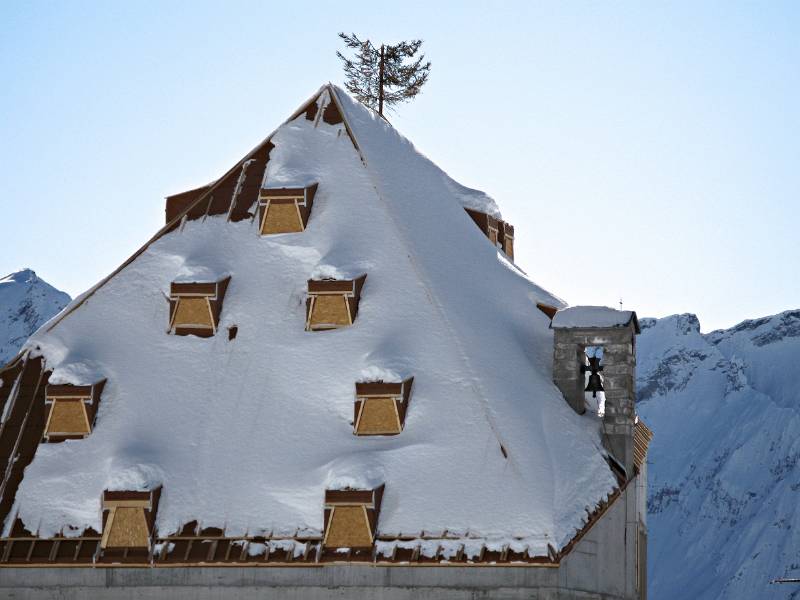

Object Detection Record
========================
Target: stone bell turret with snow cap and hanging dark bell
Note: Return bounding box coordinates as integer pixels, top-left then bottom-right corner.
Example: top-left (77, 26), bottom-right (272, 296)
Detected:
top-left (550, 306), bottom-right (640, 477)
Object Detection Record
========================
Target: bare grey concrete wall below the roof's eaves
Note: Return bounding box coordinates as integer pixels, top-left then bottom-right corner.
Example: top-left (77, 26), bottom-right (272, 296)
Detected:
top-left (0, 482), bottom-right (639, 600)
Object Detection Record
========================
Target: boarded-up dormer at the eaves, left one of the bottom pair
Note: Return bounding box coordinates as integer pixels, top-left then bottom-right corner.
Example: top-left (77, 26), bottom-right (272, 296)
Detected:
top-left (100, 488), bottom-right (161, 550)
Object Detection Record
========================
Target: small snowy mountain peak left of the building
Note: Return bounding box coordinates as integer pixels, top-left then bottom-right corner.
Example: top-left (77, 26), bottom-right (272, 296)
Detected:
top-left (0, 269), bottom-right (70, 364)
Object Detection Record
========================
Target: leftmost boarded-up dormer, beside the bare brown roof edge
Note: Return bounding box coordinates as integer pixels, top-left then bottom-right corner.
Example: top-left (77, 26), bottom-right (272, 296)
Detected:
top-left (44, 380), bottom-right (105, 442)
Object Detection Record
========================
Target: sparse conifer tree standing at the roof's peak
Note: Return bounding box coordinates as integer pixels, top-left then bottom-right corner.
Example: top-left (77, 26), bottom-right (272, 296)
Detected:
top-left (336, 33), bottom-right (431, 116)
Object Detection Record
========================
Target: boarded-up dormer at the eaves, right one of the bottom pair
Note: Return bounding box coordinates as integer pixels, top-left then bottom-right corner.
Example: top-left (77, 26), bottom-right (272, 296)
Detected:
top-left (323, 486), bottom-right (384, 549)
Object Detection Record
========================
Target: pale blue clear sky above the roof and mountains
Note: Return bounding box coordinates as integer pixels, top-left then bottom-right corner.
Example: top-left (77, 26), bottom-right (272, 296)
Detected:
top-left (0, 1), bottom-right (800, 331)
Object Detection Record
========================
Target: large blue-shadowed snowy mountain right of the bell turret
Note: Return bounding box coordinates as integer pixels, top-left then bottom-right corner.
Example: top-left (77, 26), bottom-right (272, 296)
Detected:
top-left (637, 310), bottom-right (800, 600)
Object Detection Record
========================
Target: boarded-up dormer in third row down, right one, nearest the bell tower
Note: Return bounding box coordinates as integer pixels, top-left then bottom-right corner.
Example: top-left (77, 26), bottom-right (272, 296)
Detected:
top-left (353, 377), bottom-right (414, 435)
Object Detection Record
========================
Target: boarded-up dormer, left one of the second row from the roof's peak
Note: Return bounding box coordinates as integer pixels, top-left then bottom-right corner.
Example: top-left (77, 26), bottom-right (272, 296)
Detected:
top-left (169, 277), bottom-right (230, 337)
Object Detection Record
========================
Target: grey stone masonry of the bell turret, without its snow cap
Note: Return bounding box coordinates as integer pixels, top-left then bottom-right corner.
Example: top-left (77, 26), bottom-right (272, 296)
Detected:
top-left (553, 318), bottom-right (637, 477)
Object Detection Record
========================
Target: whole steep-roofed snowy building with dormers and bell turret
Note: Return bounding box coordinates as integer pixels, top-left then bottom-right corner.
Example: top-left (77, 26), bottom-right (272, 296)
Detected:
top-left (0, 85), bottom-right (649, 599)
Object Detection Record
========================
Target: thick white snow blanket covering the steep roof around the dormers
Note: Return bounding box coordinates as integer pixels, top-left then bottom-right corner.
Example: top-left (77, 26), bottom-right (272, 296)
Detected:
top-left (6, 85), bottom-right (616, 555)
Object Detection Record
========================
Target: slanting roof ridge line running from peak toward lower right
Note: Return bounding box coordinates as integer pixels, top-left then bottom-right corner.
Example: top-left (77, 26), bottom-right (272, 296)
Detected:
top-left (328, 83), bottom-right (519, 474)
